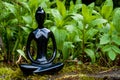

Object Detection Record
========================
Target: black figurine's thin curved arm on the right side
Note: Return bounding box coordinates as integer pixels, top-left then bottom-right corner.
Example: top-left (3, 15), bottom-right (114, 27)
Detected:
top-left (49, 32), bottom-right (57, 62)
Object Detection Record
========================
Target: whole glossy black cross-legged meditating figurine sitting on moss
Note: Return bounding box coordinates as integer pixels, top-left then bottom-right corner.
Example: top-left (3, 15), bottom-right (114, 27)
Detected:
top-left (20, 7), bottom-right (63, 74)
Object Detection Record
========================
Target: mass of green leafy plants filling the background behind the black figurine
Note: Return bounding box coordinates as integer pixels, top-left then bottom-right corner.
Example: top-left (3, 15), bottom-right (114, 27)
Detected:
top-left (0, 0), bottom-right (120, 79)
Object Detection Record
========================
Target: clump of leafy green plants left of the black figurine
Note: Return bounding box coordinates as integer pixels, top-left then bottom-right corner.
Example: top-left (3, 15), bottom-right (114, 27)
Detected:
top-left (0, 1), bottom-right (32, 62)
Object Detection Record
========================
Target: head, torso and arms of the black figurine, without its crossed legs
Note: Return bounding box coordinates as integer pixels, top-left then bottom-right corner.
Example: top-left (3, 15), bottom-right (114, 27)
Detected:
top-left (26, 7), bottom-right (57, 64)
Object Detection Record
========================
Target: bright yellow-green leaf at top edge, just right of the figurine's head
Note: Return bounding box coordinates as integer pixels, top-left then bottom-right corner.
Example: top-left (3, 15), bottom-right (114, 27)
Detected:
top-left (56, 0), bottom-right (66, 16)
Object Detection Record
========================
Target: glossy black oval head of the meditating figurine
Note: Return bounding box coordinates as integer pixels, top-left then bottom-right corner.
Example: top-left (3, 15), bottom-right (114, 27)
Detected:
top-left (35, 7), bottom-right (46, 25)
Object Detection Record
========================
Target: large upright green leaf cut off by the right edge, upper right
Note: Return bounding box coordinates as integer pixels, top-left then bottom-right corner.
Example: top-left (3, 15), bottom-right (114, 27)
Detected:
top-left (113, 8), bottom-right (120, 32)
